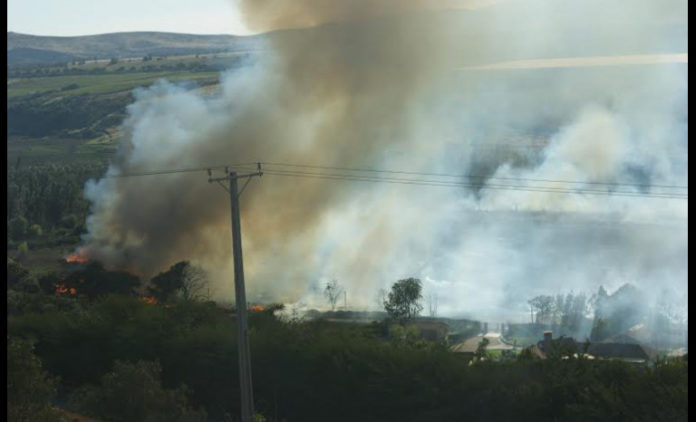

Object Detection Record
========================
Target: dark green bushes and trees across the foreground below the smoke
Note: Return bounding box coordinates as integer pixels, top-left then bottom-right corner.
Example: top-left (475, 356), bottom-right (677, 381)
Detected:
top-left (7, 244), bottom-right (687, 421)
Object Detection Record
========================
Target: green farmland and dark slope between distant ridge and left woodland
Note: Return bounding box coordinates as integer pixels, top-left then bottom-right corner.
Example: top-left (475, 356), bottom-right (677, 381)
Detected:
top-left (7, 49), bottom-right (234, 149)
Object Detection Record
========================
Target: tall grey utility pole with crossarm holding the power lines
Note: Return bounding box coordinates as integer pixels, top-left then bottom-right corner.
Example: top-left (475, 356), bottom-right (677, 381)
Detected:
top-left (208, 163), bottom-right (263, 422)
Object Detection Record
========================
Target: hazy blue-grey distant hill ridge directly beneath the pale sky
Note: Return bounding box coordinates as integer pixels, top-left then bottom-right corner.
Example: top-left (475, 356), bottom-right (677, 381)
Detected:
top-left (7, 32), bottom-right (263, 66)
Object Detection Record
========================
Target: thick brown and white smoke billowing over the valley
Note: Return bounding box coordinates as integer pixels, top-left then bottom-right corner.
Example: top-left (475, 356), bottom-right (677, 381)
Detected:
top-left (85, 0), bottom-right (687, 317)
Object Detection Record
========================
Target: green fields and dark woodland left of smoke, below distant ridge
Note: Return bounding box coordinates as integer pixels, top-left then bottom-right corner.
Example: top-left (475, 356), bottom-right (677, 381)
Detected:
top-left (6, 55), bottom-right (231, 271)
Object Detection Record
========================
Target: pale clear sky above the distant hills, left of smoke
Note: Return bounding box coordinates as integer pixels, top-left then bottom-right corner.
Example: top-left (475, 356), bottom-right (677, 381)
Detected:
top-left (7, 0), bottom-right (248, 36)
